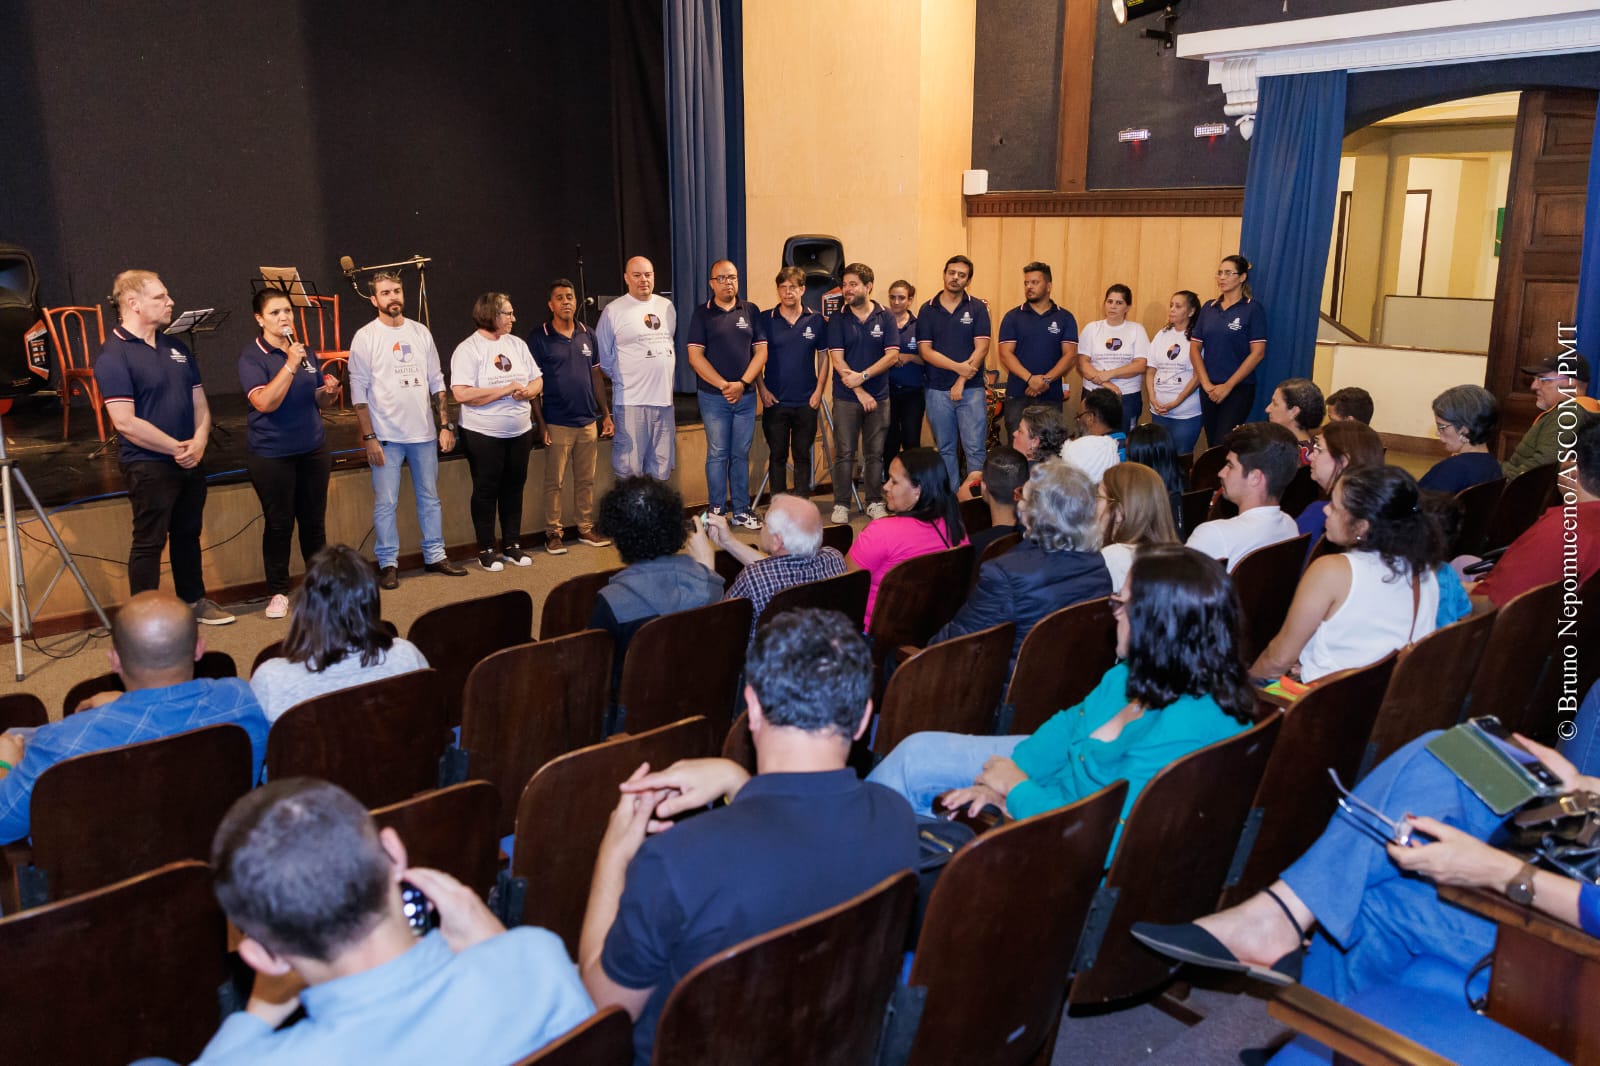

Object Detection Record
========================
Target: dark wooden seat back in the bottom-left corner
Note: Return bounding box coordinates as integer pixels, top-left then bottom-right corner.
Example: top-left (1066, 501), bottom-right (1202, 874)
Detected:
top-left (0, 863), bottom-right (227, 1063)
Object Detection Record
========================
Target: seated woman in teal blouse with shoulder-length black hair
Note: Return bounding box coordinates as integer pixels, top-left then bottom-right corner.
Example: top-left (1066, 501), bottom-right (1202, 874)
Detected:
top-left (867, 544), bottom-right (1256, 818)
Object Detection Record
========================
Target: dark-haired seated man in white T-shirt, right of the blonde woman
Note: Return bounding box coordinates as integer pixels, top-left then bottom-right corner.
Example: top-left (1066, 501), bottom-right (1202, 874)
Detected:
top-left (1189, 423), bottom-right (1299, 570)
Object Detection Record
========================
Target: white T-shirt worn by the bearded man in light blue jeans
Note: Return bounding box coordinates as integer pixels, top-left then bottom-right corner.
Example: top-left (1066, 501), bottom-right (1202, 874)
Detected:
top-left (350, 319), bottom-right (445, 443)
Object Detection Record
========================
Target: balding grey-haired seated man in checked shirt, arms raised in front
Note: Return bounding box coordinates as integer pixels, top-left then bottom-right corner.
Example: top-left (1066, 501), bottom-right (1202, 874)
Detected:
top-left (690, 493), bottom-right (845, 640)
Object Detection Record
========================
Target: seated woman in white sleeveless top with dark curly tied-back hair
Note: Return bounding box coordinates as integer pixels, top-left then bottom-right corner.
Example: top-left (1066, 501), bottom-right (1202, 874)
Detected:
top-left (1250, 466), bottom-right (1445, 682)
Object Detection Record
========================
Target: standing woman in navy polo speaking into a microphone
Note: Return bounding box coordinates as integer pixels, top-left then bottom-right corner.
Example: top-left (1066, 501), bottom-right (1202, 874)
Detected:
top-left (238, 288), bottom-right (339, 618)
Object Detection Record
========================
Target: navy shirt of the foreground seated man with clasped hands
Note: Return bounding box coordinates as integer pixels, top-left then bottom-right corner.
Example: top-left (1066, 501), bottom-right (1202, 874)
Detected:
top-left (600, 765), bottom-right (917, 1064)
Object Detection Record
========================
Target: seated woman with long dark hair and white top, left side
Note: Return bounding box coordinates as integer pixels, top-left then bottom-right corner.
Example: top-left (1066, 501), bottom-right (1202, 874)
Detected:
top-left (250, 544), bottom-right (427, 722)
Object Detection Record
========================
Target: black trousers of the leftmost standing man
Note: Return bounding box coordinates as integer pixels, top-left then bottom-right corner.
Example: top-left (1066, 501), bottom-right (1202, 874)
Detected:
top-left (122, 459), bottom-right (205, 603)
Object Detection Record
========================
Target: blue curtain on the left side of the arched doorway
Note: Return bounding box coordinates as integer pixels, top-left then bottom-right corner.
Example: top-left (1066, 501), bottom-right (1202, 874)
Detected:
top-left (1238, 70), bottom-right (1346, 419)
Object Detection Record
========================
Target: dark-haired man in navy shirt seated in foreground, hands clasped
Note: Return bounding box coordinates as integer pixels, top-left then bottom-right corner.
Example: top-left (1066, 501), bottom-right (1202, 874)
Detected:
top-left (578, 610), bottom-right (917, 1066)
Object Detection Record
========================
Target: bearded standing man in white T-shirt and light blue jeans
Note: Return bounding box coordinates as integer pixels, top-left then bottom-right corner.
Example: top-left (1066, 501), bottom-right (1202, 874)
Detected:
top-left (350, 271), bottom-right (467, 589)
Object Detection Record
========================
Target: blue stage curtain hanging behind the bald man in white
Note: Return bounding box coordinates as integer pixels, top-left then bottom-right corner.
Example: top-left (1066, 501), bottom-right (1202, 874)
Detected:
top-left (656, 0), bottom-right (744, 392)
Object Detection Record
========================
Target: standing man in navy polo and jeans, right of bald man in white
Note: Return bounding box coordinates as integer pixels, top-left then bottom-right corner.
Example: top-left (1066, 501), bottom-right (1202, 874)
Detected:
top-left (688, 259), bottom-right (766, 530)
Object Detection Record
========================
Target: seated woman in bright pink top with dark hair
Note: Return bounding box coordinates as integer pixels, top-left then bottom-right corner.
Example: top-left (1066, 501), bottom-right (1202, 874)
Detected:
top-left (846, 448), bottom-right (966, 629)
